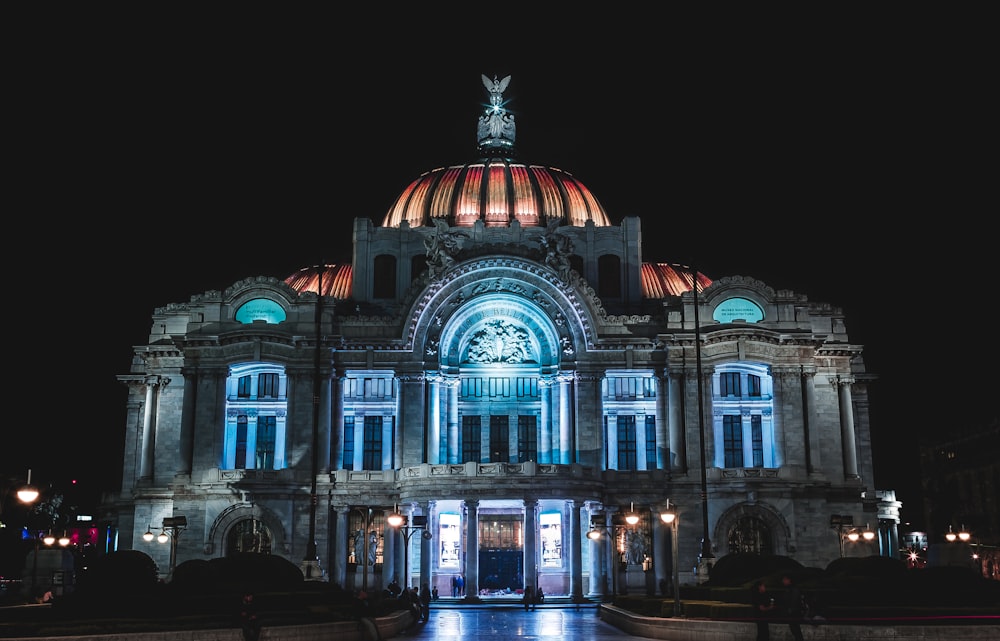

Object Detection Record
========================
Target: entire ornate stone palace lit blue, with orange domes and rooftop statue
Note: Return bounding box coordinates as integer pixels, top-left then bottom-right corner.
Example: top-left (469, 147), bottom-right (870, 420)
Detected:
top-left (114, 76), bottom-right (898, 599)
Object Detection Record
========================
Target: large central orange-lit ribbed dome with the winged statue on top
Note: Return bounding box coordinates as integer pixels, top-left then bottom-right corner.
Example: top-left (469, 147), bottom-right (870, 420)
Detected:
top-left (382, 76), bottom-right (611, 227)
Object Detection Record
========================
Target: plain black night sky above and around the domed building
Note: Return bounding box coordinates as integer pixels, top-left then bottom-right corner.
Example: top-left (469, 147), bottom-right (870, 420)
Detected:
top-left (0, 17), bottom-right (998, 518)
